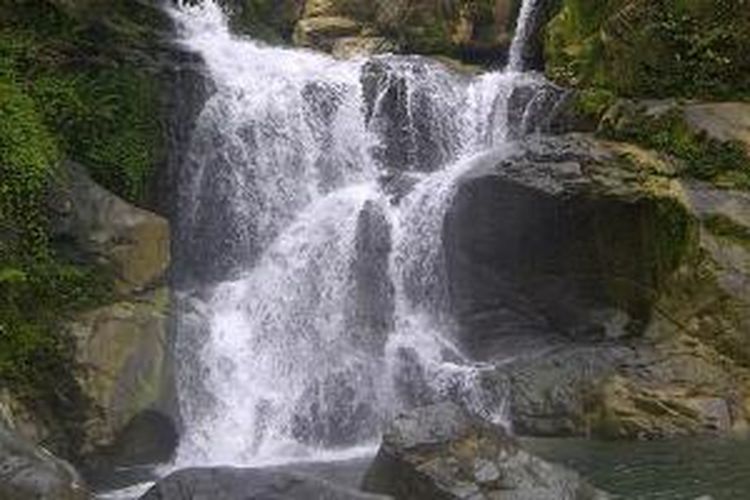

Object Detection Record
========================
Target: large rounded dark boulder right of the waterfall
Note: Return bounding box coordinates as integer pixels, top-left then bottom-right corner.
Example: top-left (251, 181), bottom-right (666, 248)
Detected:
top-left (443, 137), bottom-right (692, 357)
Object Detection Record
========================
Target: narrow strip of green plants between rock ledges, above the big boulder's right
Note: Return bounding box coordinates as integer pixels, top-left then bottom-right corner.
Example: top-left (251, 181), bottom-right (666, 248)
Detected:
top-left (599, 107), bottom-right (750, 189)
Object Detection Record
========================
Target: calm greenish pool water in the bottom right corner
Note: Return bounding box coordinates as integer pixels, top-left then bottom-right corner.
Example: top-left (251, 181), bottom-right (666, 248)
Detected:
top-left (524, 437), bottom-right (750, 500)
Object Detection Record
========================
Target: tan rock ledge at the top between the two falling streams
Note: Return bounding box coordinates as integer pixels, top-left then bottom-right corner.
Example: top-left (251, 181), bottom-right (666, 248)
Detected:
top-left (224, 0), bottom-right (540, 63)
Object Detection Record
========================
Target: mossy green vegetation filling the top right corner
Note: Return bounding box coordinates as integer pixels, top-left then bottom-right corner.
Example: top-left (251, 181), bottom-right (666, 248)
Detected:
top-left (545, 0), bottom-right (750, 99)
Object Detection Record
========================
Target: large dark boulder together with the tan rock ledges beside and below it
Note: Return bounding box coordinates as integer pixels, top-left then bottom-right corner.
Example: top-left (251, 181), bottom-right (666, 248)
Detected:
top-left (444, 136), bottom-right (750, 439)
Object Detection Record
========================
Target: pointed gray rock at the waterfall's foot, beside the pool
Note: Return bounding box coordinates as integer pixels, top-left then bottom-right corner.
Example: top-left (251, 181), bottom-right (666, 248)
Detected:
top-left (364, 403), bottom-right (607, 500)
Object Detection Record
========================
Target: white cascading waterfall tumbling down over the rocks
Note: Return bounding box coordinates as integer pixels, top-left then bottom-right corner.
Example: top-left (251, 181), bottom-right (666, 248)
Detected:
top-left (173, 0), bottom-right (552, 465)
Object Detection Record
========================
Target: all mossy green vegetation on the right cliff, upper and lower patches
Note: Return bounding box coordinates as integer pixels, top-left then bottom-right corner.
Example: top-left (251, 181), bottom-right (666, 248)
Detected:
top-left (545, 0), bottom-right (750, 189)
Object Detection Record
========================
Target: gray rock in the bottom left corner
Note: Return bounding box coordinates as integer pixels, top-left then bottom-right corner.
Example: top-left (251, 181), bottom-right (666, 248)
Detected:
top-left (0, 424), bottom-right (90, 500)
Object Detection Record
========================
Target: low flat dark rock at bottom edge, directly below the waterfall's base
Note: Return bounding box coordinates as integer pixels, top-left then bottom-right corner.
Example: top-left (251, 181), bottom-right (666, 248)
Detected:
top-left (141, 468), bottom-right (386, 500)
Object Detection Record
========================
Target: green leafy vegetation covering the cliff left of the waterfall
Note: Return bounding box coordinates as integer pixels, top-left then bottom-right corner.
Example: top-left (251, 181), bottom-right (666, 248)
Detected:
top-left (0, 0), bottom-right (169, 454)
